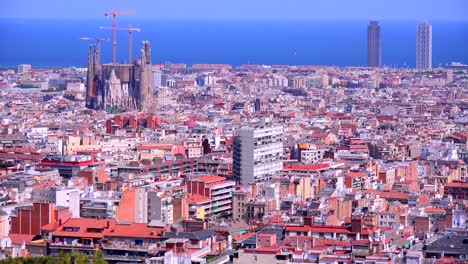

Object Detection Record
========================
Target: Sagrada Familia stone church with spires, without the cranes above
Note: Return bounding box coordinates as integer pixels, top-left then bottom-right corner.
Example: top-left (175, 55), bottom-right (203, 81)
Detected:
top-left (86, 41), bottom-right (153, 111)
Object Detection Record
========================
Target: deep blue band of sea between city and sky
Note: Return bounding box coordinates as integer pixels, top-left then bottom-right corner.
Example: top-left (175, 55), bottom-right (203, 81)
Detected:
top-left (0, 17), bottom-right (468, 68)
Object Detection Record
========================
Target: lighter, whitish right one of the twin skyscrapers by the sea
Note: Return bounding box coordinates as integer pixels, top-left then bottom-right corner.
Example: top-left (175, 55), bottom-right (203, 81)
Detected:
top-left (416, 22), bottom-right (432, 69)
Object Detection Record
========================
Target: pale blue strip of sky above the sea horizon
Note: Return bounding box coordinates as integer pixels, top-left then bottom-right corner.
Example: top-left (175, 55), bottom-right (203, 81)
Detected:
top-left (0, 0), bottom-right (468, 20)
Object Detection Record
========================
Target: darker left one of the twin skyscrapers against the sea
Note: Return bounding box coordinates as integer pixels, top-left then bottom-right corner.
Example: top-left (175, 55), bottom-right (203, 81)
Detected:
top-left (367, 21), bottom-right (382, 67)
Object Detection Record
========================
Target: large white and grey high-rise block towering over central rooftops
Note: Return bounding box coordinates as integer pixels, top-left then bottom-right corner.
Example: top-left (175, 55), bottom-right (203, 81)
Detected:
top-left (233, 126), bottom-right (283, 184)
